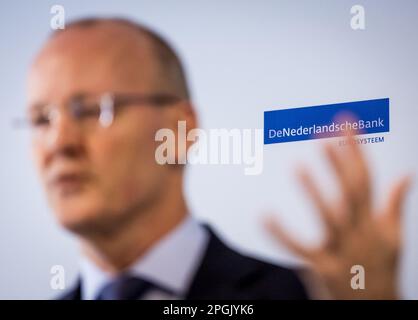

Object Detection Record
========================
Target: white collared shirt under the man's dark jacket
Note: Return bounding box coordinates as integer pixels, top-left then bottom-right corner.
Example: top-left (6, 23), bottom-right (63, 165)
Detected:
top-left (80, 216), bottom-right (209, 300)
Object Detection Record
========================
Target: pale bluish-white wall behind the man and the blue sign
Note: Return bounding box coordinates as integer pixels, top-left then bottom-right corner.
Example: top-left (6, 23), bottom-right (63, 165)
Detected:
top-left (0, 0), bottom-right (418, 299)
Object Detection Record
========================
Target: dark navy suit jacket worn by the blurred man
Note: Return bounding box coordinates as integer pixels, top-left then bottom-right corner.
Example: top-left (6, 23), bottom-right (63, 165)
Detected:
top-left (60, 228), bottom-right (308, 300)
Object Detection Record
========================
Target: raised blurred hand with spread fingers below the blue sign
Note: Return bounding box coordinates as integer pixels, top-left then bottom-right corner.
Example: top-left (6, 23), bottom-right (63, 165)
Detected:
top-left (267, 133), bottom-right (411, 299)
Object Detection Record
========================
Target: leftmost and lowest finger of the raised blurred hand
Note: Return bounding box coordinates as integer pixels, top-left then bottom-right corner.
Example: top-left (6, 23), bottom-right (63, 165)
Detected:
top-left (264, 217), bottom-right (313, 260)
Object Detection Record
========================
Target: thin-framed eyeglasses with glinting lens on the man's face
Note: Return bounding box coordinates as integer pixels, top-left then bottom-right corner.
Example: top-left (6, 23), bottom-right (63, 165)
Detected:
top-left (16, 93), bottom-right (182, 131)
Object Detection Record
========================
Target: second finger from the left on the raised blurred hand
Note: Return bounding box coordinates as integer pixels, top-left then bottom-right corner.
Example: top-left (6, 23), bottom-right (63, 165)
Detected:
top-left (298, 168), bottom-right (338, 238)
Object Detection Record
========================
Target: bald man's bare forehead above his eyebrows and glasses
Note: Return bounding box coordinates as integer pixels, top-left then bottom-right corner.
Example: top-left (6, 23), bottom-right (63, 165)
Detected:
top-left (29, 22), bottom-right (155, 99)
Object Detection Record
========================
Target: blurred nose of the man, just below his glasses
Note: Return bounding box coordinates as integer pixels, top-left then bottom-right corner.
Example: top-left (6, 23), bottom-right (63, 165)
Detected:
top-left (44, 109), bottom-right (83, 158)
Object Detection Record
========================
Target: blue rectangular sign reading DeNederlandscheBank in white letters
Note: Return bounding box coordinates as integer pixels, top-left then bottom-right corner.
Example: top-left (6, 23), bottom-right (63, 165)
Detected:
top-left (264, 98), bottom-right (389, 144)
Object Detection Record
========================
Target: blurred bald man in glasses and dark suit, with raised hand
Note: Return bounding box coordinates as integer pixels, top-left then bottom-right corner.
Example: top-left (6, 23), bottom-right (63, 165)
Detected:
top-left (28, 19), bottom-right (408, 299)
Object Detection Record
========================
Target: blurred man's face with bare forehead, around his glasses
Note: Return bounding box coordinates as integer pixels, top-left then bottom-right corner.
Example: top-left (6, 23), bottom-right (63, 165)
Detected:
top-left (28, 26), bottom-right (176, 232)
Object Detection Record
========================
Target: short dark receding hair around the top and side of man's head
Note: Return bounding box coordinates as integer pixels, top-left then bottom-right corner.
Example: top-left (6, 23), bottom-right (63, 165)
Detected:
top-left (52, 17), bottom-right (190, 99)
